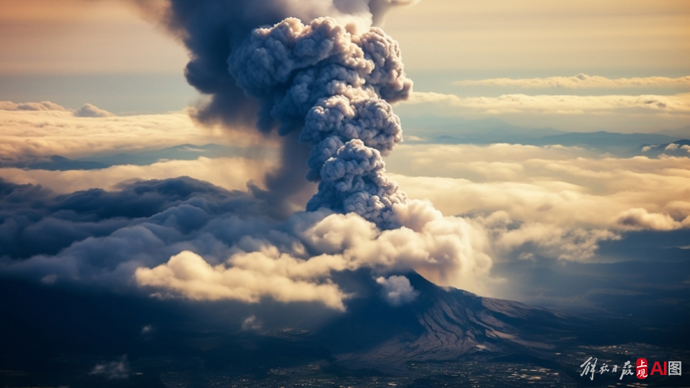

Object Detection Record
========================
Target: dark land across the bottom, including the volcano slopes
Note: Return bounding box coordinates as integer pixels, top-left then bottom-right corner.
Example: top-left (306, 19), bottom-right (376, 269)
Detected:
top-left (0, 272), bottom-right (690, 387)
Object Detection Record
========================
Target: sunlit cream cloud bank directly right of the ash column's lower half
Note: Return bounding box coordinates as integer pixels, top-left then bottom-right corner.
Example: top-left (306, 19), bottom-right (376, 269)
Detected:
top-left (388, 144), bottom-right (690, 260)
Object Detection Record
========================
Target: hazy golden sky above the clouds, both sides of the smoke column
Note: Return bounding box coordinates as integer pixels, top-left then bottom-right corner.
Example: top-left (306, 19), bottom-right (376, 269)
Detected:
top-left (0, 0), bottom-right (690, 132)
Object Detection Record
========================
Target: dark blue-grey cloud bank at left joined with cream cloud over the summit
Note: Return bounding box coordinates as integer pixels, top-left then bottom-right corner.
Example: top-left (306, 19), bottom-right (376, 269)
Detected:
top-left (0, 178), bottom-right (492, 311)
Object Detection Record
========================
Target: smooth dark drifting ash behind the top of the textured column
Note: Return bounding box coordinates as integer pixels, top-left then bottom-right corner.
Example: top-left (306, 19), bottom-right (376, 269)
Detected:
top-left (134, 0), bottom-right (416, 130)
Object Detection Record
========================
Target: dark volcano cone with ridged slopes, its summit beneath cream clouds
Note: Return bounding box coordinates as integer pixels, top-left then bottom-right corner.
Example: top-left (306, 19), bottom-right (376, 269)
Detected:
top-left (318, 273), bottom-right (586, 367)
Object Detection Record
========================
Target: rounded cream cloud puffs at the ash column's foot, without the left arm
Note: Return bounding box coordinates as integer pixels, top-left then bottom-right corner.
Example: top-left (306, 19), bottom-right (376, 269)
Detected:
top-left (302, 200), bottom-right (493, 293)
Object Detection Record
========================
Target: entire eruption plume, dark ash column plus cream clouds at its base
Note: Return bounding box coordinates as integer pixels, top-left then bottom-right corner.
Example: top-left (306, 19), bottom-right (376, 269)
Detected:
top-left (103, 0), bottom-right (492, 311)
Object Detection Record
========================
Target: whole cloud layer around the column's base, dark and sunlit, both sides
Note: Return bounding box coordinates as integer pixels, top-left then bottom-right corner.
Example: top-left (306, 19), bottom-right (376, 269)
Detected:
top-left (0, 97), bottom-right (690, 311)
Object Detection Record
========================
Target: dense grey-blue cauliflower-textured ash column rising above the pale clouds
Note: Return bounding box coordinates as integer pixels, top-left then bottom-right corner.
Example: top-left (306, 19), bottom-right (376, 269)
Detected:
top-left (228, 18), bottom-right (412, 227)
